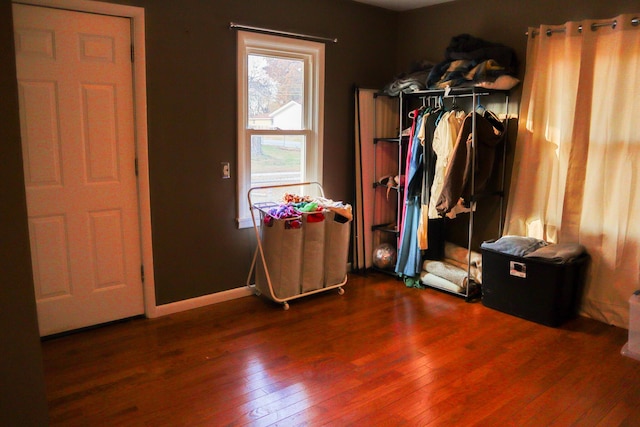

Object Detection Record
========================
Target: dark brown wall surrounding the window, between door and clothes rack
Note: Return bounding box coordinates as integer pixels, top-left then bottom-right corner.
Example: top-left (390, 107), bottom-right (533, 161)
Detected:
top-left (102, 0), bottom-right (397, 304)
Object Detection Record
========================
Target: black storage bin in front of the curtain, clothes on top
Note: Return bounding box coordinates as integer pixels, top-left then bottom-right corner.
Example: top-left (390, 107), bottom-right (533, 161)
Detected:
top-left (482, 248), bottom-right (589, 327)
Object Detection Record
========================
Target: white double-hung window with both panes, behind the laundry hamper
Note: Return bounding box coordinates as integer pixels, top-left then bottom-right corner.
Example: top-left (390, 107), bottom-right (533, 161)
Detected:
top-left (238, 31), bottom-right (324, 228)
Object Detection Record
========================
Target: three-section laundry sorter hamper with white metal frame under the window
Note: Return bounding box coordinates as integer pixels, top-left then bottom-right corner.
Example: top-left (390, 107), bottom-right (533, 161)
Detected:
top-left (247, 182), bottom-right (351, 310)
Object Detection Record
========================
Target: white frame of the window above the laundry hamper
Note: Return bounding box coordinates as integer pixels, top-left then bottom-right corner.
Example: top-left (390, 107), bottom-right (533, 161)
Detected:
top-left (236, 31), bottom-right (325, 228)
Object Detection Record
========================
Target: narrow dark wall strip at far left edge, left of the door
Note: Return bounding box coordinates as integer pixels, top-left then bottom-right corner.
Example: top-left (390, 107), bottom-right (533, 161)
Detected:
top-left (0, 0), bottom-right (47, 427)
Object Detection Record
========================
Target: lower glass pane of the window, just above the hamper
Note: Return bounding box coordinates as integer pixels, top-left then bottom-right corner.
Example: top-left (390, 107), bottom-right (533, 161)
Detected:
top-left (251, 135), bottom-right (305, 193)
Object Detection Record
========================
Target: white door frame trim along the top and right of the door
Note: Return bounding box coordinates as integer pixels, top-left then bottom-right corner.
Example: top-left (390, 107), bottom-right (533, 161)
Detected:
top-left (13, 0), bottom-right (157, 317)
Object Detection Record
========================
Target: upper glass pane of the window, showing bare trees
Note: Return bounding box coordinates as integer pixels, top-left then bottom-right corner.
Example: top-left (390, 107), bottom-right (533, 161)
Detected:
top-left (247, 55), bottom-right (304, 130)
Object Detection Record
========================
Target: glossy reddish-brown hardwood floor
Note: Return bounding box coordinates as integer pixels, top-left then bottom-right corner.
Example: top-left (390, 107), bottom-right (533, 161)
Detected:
top-left (43, 274), bottom-right (640, 427)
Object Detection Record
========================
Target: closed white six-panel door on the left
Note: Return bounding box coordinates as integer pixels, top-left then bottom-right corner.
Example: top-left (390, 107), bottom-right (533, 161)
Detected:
top-left (13, 4), bottom-right (144, 336)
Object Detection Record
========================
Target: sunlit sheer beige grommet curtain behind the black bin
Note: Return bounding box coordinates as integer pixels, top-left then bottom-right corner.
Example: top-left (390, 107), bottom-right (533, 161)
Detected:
top-left (505, 15), bottom-right (640, 328)
